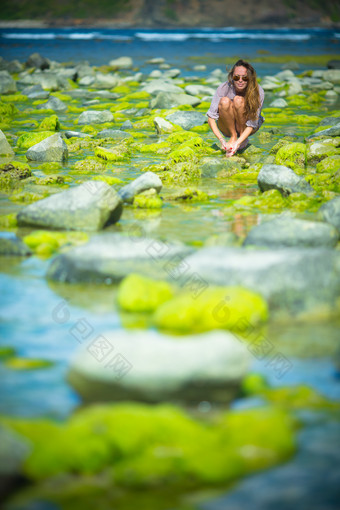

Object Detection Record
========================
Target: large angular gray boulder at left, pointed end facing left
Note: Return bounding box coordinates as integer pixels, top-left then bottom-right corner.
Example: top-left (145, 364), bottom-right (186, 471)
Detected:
top-left (17, 181), bottom-right (122, 231)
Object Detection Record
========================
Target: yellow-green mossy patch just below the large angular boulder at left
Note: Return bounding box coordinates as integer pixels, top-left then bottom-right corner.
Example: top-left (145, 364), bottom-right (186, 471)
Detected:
top-left (23, 230), bottom-right (88, 258)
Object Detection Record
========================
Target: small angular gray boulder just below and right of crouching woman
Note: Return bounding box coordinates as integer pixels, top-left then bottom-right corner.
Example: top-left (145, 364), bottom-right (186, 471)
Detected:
top-left (257, 165), bottom-right (313, 196)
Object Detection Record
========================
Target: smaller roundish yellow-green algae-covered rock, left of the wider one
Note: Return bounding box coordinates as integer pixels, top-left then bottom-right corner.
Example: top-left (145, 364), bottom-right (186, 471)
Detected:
top-left (117, 273), bottom-right (174, 312)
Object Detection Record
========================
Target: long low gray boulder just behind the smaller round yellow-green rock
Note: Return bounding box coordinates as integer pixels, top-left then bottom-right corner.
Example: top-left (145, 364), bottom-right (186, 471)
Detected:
top-left (47, 234), bottom-right (193, 283)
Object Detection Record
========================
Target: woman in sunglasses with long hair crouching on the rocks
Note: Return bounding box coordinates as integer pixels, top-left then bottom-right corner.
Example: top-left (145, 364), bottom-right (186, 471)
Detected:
top-left (207, 60), bottom-right (264, 157)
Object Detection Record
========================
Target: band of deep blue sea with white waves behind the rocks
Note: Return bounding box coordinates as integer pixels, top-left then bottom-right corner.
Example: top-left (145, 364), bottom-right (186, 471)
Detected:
top-left (0, 27), bottom-right (340, 67)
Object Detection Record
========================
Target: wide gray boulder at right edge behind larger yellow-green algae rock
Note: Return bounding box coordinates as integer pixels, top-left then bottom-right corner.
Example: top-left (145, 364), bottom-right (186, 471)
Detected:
top-left (174, 247), bottom-right (340, 316)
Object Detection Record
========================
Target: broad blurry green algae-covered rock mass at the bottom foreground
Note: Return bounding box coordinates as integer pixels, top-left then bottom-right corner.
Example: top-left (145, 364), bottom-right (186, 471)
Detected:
top-left (2, 403), bottom-right (295, 486)
